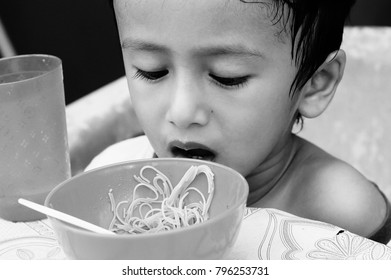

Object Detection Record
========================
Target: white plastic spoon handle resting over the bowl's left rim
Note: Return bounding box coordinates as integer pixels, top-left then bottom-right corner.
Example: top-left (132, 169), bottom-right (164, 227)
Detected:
top-left (18, 198), bottom-right (115, 235)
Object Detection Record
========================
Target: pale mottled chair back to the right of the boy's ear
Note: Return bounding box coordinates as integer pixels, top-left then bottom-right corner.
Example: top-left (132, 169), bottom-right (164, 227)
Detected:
top-left (298, 27), bottom-right (391, 199)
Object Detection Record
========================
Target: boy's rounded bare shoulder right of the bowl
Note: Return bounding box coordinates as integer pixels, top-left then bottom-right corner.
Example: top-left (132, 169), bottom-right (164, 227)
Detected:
top-left (296, 137), bottom-right (386, 236)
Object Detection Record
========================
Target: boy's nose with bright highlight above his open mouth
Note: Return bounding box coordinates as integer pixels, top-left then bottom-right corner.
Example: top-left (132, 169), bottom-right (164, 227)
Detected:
top-left (167, 75), bottom-right (211, 129)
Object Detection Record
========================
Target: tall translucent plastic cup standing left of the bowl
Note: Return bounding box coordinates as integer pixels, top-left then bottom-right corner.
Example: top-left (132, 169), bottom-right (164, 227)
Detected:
top-left (0, 55), bottom-right (71, 221)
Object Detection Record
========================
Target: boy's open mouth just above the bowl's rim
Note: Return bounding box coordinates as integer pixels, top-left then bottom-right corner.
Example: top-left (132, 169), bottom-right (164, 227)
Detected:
top-left (171, 143), bottom-right (216, 161)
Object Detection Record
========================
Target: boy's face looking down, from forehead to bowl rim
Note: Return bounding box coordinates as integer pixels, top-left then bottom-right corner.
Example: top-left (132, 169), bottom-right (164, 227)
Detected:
top-left (114, 0), bottom-right (296, 176)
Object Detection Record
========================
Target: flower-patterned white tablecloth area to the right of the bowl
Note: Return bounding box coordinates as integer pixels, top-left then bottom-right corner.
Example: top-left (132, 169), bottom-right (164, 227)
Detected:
top-left (229, 208), bottom-right (391, 260)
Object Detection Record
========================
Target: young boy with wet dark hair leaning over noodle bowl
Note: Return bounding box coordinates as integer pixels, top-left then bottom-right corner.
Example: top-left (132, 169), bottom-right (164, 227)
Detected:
top-left (89, 0), bottom-right (391, 242)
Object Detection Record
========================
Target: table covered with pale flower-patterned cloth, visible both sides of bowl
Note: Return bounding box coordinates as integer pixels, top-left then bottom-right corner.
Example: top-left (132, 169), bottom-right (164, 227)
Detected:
top-left (0, 208), bottom-right (391, 260)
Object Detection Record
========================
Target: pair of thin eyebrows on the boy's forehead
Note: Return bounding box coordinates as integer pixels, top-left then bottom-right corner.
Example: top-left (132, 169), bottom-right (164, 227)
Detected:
top-left (121, 38), bottom-right (265, 58)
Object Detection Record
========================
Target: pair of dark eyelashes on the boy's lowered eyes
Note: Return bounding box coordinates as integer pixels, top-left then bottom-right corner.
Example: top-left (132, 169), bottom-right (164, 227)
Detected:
top-left (134, 69), bottom-right (249, 89)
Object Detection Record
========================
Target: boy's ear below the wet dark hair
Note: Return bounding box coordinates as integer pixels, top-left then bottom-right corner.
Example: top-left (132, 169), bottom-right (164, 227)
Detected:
top-left (298, 50), bottom-right (346, 118)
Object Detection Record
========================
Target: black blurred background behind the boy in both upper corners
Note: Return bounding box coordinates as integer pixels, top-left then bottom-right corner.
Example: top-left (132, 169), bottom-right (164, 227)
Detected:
top-left (0, 0), bottom-right (391, 103)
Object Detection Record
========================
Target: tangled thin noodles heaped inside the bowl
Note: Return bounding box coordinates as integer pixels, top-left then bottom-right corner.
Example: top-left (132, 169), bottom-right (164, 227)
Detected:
top-left (108, 165), bottom-right (214, 234)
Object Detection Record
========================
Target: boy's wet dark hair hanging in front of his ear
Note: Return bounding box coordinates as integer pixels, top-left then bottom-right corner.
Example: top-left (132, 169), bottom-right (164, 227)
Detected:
top-left (109, 0), bottom-right (356, 122)
